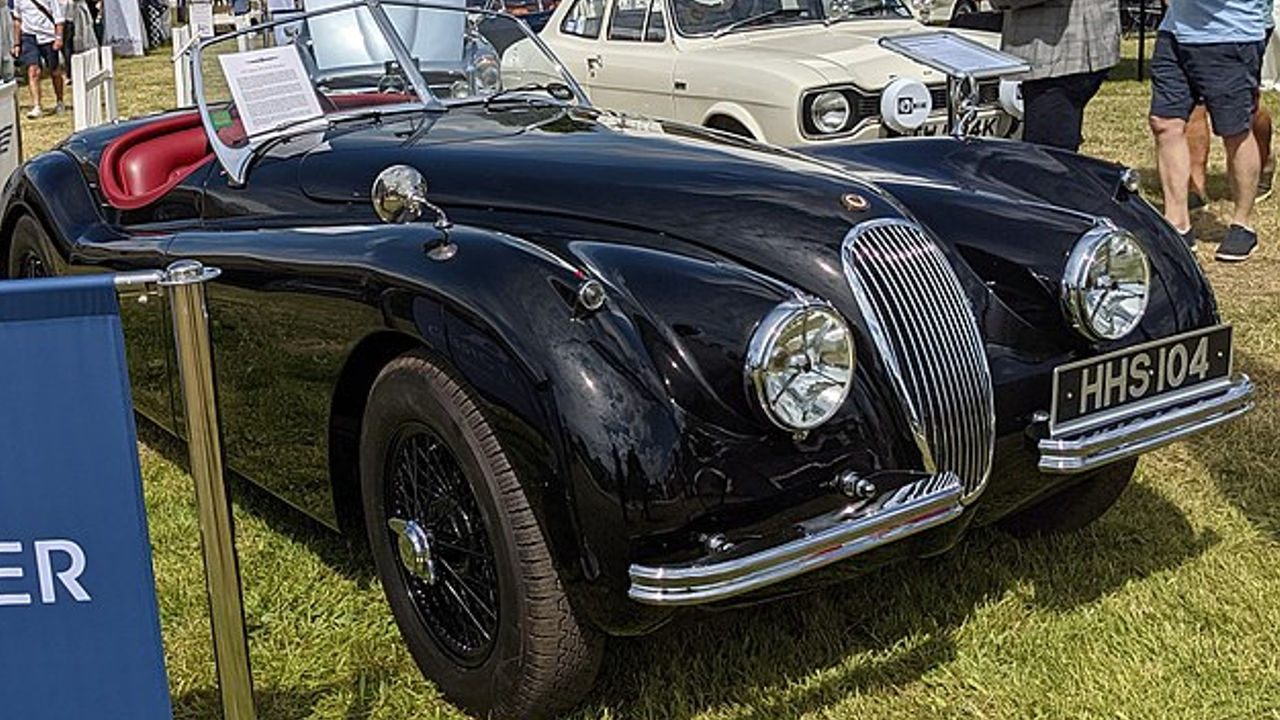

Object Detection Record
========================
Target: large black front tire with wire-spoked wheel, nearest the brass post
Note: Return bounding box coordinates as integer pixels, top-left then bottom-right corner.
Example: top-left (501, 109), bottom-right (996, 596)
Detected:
top-left (360, 352), bottom-right (604, 719)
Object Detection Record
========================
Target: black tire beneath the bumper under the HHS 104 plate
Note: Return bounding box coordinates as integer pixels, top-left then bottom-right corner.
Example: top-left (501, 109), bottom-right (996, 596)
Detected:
top-left (998, 459), bottom-right (1138, 538)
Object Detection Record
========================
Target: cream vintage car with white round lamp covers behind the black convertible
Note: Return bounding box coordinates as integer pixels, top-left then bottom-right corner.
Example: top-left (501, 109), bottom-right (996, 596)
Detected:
top-left (540, 0), bottom-right (1019, 146)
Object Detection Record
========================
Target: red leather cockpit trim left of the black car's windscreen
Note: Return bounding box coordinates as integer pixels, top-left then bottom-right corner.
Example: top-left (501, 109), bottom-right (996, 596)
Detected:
top-left (99, 113), bottom-right (214, 210)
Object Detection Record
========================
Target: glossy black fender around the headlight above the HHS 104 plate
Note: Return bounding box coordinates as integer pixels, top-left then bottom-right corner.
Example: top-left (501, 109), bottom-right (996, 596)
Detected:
top-left (813, 138), bottom-right (1217, 352)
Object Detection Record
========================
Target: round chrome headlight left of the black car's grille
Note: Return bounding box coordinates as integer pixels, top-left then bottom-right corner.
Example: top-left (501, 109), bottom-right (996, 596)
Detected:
top-left (746, 299), bottom-right (854, 430)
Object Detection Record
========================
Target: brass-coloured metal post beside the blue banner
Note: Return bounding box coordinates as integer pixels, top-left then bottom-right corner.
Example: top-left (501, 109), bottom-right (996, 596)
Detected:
top-left (160, 260), bottom-right (257, 720)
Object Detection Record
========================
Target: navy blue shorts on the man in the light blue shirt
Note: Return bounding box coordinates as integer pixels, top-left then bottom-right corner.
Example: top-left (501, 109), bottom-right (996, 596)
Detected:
top-left (1151, 32), bottom-right (1262, 137)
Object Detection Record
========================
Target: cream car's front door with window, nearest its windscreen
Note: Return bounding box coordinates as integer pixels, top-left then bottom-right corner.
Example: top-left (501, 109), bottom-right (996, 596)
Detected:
top-left (590, 0), bottom-right (676, 118)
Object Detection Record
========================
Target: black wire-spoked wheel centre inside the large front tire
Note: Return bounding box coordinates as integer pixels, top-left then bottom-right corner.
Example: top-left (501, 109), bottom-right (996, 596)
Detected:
top-left (384, 423), bottom-right (499, 666)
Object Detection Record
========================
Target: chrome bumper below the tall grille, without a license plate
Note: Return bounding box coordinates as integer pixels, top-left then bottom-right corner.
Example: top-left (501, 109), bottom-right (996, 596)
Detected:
top-left (628, 473), bottom-right (964, 606)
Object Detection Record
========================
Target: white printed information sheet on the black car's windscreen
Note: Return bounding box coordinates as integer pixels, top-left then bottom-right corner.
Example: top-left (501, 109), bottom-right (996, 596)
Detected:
top-left (218, 45), bottom-right (324, 137)
